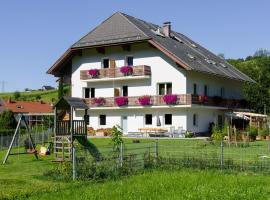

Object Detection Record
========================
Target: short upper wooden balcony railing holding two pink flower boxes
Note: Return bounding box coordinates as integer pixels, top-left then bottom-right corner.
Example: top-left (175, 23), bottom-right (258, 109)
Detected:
top-left (80, 65), bottom-right (151, 80)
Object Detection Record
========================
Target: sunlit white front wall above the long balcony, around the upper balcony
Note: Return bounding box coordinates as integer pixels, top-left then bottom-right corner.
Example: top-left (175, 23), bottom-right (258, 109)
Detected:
top-left (71, 43), bottom-right (186, 97)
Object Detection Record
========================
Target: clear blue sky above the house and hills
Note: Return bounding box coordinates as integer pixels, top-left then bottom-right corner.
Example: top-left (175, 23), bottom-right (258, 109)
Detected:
top-left (0, 0), bottom-right (270, 92)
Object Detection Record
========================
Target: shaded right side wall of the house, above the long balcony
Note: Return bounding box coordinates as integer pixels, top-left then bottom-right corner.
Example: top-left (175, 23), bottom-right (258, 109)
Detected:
top-left (187, 72), bottom-right (243, 99)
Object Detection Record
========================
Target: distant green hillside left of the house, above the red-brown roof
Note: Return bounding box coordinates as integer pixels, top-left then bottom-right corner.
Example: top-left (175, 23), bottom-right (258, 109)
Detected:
top-left (0, 90), bottom-right (58, 102)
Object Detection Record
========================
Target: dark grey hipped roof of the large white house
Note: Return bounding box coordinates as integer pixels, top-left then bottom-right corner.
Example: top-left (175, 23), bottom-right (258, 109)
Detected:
top-left (48, 12), bottom-right (254, 82)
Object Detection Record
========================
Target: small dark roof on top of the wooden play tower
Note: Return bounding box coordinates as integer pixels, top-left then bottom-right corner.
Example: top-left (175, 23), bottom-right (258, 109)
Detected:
top-left (54, 96), bottom-right (88, 109)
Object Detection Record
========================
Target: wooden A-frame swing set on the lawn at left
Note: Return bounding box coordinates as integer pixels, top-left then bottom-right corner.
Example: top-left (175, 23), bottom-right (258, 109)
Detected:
top-left (3, 115), bottom-right (53, 164)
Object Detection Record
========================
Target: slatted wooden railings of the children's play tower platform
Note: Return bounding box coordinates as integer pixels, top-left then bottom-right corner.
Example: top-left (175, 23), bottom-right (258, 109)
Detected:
top-left (55, 120), bottom-right (86, 136)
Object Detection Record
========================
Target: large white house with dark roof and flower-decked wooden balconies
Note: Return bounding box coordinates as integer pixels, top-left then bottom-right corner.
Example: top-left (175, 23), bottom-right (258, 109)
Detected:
top-left (48, 12), bottom-right (254, 133)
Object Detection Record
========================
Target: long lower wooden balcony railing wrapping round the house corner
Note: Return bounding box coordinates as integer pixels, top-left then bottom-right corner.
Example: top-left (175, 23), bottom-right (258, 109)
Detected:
top-left (85, 94), bottom-right (247, 108)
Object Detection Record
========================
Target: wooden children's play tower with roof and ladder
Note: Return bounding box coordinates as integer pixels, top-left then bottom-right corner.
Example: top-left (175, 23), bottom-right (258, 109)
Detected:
top-left (54, 97), bottom-right (89, 162)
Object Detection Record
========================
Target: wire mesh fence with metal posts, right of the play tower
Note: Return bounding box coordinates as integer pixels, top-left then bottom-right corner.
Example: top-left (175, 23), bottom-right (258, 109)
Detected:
top-left (73, 139), bottom-right (270, 178)
